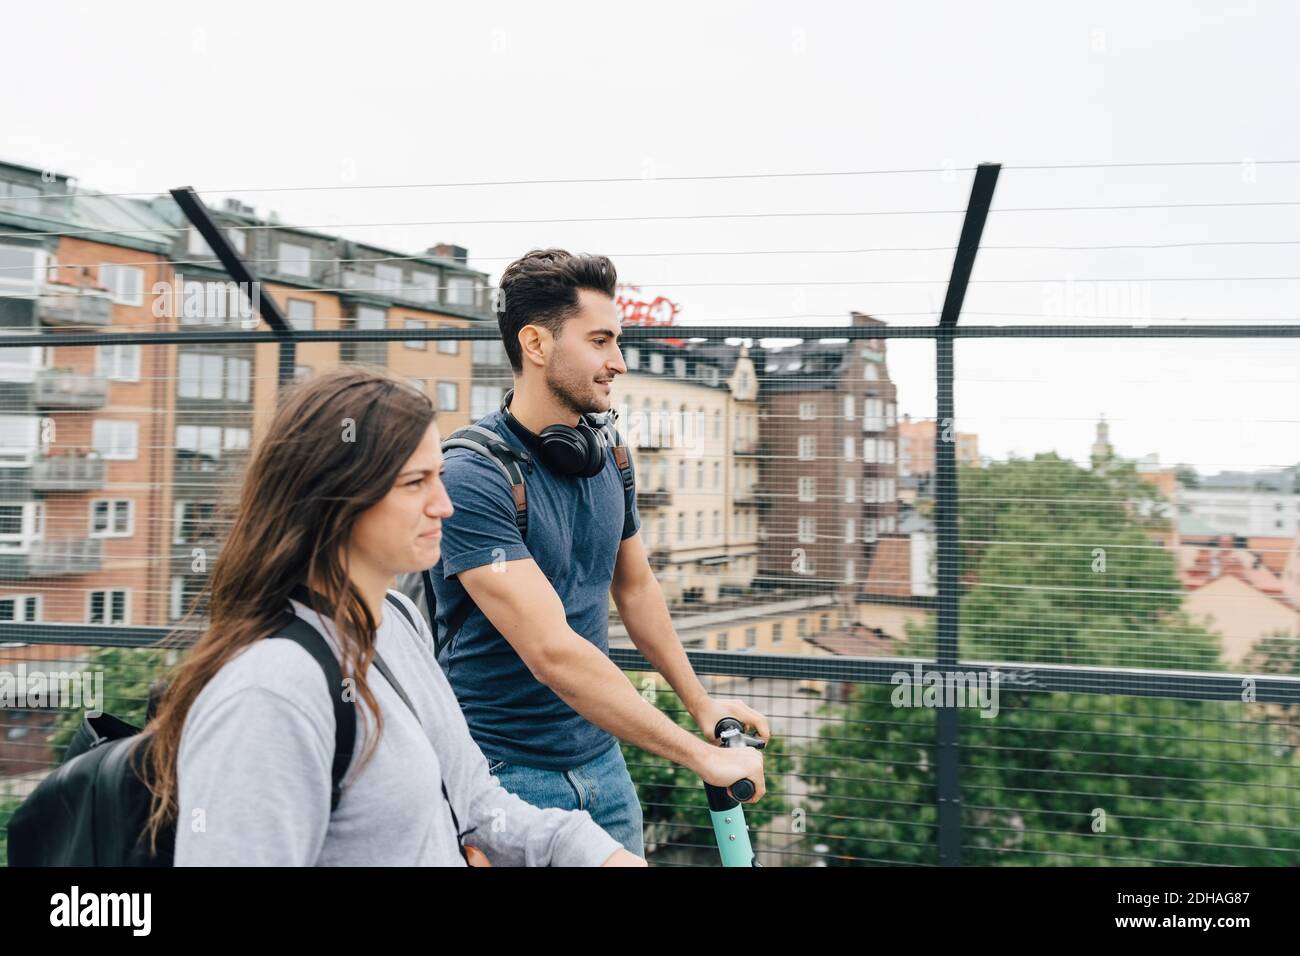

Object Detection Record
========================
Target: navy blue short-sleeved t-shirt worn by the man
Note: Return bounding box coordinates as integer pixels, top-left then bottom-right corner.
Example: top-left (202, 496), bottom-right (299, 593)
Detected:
top-left (432, 411), bottom-right (641, 770)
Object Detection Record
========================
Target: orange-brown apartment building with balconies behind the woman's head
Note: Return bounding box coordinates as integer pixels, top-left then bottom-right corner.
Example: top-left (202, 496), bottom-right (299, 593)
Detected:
top-left (0, 164), bottom-right (495, 626)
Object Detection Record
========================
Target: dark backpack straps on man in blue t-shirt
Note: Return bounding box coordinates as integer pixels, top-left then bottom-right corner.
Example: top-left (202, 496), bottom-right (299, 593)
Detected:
top-left (397, 419), bottom-right (637, 661)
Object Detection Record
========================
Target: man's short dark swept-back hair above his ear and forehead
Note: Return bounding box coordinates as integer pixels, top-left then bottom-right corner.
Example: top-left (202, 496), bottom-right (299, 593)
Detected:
top-left (497, 248), bottom-right (619, 372)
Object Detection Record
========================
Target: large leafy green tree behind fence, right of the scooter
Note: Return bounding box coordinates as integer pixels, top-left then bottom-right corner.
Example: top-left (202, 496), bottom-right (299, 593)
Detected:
top-left (803, 455), bottom-right (1300, 865)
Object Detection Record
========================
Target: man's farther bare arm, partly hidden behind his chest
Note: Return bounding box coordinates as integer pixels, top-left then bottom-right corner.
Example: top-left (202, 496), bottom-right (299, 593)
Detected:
top-left (610, 532), bottom-right (771, 740)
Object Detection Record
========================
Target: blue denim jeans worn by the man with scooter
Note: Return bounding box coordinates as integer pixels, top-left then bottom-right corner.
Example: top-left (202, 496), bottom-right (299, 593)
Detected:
top-left (488, 743), bottom-right (646, 856)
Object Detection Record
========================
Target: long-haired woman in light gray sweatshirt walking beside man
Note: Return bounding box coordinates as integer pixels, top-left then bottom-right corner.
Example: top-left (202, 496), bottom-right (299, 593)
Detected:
top-left (141, 368), bottom-right (645, 866)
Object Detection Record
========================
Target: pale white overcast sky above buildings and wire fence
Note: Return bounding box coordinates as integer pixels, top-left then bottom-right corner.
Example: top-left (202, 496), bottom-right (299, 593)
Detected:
top-left (0, 0), bottom-right (1300, 473)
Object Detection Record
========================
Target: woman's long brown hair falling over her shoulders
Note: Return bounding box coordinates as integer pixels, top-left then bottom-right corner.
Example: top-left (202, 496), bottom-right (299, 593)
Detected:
top-left (142, 367), bottom-right (434, 852)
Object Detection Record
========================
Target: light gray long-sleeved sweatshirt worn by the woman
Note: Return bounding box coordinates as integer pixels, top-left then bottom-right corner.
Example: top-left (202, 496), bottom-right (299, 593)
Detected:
top-left (176, 592), bottom-right (619, 866)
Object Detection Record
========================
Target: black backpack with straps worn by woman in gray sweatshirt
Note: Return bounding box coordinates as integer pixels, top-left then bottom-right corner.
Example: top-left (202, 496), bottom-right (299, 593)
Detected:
top-left (9, 593), bottom-right (465, 866)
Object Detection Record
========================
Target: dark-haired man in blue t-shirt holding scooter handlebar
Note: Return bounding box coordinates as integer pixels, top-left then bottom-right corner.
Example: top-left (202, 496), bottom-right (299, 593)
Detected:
top-left (406, 250), bottom-right (770, 856)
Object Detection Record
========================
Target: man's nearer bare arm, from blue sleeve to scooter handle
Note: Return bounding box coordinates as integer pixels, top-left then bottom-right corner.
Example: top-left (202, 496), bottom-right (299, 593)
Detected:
top-left (460, 558), bottom-right (764, 800)
